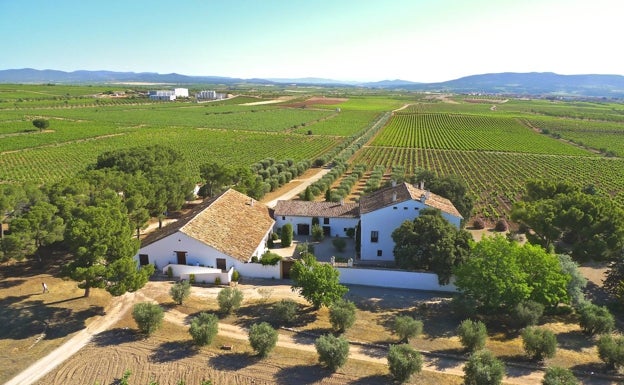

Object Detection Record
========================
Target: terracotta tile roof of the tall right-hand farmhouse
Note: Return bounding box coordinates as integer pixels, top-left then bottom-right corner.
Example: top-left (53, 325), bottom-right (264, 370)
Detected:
top-left (360, 183), bottom-right (463, 218)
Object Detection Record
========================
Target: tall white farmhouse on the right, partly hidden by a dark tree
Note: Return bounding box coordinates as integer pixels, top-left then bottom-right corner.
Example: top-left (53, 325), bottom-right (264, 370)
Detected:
top-left (360, 183), bottom-right (462, 261)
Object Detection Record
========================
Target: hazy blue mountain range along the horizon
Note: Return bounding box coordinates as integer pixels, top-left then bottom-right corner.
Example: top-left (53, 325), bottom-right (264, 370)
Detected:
top-left (0, 68), bottom-right (624, 98)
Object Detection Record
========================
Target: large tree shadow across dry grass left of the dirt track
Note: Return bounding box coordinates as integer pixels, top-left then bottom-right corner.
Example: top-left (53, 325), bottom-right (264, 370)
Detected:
top-left (0, 295), bottom-right (104, 340)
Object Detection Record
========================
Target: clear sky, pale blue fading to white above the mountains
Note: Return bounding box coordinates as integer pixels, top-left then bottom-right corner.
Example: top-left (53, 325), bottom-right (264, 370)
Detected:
top-left (0, 0), bottom-right (624, 82)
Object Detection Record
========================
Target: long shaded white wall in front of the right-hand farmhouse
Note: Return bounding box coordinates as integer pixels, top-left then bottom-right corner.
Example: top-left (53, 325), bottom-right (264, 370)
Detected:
top-left (336, 267), bottom-right (457, 293)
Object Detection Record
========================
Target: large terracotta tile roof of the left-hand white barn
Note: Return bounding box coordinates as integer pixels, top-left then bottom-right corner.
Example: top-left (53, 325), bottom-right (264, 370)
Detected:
top-left (142, 189), bottom-right (275, 262)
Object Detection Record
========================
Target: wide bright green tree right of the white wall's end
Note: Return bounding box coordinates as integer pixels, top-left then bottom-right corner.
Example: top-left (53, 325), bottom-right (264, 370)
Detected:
top-left (455, 235), bottom-right (570, 311)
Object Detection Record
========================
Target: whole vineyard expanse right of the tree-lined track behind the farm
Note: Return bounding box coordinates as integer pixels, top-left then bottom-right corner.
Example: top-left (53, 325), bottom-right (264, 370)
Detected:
top-left (351, 101), bottom-right (624, 221)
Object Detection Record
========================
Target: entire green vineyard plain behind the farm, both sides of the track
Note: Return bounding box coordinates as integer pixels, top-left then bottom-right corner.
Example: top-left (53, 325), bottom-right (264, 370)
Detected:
top-left (0, 85), bottom-right (624, 220)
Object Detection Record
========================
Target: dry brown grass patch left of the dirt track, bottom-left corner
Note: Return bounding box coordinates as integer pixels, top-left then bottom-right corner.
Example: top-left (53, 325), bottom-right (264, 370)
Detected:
top-left (0, 266), bottom-right (111, 383)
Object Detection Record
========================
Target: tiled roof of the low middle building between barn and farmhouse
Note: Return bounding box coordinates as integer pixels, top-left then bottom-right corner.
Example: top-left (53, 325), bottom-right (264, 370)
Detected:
top-left (274, 201), bottom-right (359, 218)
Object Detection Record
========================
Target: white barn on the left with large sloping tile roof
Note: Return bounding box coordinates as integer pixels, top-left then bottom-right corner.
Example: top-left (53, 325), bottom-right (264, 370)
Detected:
top-left (135, 189), bottom-right (280, 283)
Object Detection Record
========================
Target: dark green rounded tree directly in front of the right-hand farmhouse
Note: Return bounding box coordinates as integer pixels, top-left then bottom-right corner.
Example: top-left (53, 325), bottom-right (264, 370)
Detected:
top-left (392, 209), bottom-right (472, 285)
